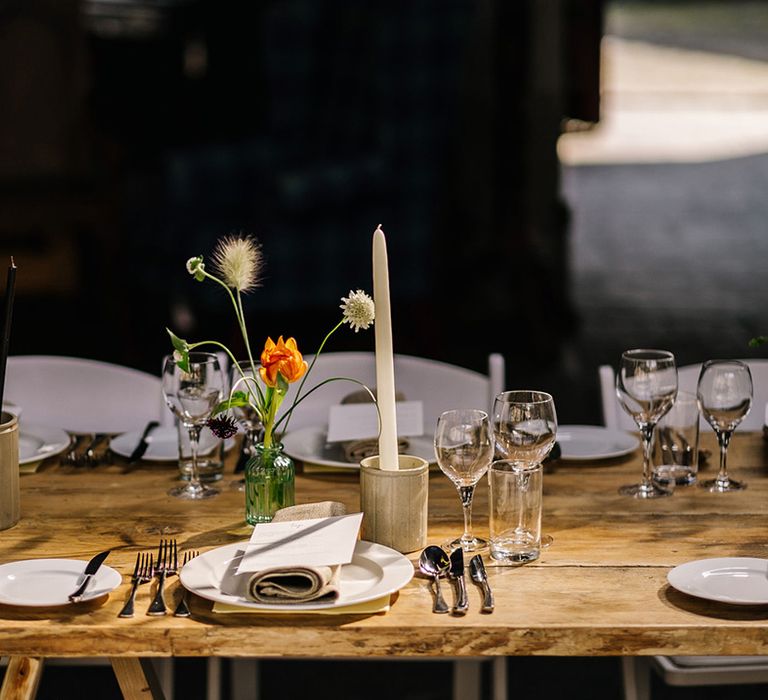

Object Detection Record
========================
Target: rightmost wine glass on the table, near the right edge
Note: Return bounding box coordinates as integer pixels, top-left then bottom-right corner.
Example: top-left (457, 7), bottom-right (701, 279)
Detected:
top-left (696, 360), bottom-right (752, 493)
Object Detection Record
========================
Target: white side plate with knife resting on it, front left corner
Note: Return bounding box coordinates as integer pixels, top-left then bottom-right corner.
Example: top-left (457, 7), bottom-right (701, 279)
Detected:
top-left (0, 559), bottom-right (123, 606)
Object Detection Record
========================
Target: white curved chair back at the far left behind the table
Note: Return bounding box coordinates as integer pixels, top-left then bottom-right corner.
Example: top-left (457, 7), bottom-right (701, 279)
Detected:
top-left (5, 355), bottom-right (164, 433)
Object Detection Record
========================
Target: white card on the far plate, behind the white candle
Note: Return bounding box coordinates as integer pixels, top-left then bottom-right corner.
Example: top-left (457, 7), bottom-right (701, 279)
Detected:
top-left (326, 401), bottom-right (424, 442)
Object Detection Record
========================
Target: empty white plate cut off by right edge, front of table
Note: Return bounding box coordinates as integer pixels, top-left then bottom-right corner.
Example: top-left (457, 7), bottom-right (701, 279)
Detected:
top-left (667, 557), bottom-right (768, 605)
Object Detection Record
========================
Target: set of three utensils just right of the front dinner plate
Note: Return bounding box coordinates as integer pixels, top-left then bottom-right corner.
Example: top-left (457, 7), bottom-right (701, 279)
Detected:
top-left (419, 545), bottom-right (494, 615)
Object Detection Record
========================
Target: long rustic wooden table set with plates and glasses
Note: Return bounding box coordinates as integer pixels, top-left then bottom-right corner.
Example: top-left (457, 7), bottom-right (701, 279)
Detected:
top-left (0, 433), bottom-right (768, 697)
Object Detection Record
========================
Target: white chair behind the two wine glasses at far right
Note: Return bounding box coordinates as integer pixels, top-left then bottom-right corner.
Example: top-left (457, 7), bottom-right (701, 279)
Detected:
top-left (599, 360), bottom-right (768, 700)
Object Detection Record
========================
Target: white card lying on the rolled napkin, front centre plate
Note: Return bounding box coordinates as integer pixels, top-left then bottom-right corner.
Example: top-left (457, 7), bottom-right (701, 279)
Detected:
top-left (237, 513), bottom-right (363, 574)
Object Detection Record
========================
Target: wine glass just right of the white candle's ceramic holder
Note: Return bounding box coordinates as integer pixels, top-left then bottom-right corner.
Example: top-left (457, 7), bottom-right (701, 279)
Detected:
top-left (435, 408), bottom-right (493, 552)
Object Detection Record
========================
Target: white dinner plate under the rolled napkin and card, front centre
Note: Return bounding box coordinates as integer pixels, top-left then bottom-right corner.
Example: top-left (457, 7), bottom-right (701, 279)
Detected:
top-left (179, 541), bottom-right (413, 612)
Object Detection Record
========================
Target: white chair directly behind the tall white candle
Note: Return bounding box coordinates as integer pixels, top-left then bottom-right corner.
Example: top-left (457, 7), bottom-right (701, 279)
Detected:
top-left (225, 352), bottom-right (507, 700)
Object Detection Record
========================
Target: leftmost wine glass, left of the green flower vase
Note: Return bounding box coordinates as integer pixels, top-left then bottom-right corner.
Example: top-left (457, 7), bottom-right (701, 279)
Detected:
top-left (163, 352), bottom-right (224, 500)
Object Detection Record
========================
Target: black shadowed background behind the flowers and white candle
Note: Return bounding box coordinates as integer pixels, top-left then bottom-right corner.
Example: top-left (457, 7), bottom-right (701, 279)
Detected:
top-left (0, 0), bottom-right (602, 394)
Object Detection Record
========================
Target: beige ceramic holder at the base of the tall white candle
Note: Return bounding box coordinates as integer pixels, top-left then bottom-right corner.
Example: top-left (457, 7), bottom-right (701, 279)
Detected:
top-left (360, 455), bottom-right (429, 554)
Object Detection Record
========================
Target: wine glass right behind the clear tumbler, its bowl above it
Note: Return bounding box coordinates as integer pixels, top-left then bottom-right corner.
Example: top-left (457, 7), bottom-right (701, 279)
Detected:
top-left (493, 389), bottom-right (557, 547)
